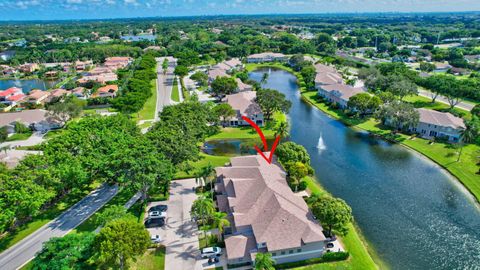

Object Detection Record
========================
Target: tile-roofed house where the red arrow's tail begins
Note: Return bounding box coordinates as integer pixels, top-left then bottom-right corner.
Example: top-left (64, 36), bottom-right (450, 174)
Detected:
top-left (224, 91), bottom-right (265, 127)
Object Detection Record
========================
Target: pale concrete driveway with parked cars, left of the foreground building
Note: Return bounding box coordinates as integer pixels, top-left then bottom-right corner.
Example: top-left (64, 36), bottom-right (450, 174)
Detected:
top-left (148, 179), bottom-right (203, 270)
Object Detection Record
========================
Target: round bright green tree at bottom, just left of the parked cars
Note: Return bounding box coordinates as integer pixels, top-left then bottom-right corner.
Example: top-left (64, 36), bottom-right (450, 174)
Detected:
top-left (93, 219), bottom-right (150, 269)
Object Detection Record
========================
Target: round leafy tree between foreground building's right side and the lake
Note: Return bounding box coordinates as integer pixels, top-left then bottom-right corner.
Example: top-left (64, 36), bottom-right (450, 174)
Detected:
top-left (311, 195), bottom-right (353, 236)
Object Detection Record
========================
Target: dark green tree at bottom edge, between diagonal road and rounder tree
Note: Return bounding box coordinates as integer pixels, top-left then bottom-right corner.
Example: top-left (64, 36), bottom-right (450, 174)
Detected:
top-left (31, 233), bottom-right (95, 270)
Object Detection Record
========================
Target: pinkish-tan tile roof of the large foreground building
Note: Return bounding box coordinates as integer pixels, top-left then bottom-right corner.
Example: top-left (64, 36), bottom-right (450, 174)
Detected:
top-left (216, 153), bottom-right (326, 252)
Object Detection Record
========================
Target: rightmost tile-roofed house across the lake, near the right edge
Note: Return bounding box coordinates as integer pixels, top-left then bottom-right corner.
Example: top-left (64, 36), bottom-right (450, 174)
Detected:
top-left (411, 108), bottom-right (465, 142)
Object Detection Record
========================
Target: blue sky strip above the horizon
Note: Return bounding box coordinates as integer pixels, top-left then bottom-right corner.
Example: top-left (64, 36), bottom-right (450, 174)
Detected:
top-left (0, 0), bottom-right (480, 21)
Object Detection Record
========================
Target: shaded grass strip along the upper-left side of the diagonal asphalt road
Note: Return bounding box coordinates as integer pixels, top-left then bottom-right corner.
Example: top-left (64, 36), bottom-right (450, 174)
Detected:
top-left (0, 183), bottom-right (99, 252)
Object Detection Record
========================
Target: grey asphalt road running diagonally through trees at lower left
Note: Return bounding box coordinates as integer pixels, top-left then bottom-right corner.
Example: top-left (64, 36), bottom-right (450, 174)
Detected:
top-left (0, 182), bottom-right (118, 270)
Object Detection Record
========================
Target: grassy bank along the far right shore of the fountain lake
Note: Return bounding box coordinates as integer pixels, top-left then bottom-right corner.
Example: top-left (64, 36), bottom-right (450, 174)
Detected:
top-left (302, 92), bottom-right (480, 202)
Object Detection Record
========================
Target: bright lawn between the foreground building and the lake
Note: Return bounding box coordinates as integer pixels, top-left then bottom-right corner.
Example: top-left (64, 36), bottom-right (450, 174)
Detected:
top-left (295, 176), bottom-right (383, 270)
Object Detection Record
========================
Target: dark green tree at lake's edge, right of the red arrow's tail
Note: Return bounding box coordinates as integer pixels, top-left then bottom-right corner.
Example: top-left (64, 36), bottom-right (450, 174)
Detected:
top-left (257, 89), bottom-right (292, 120)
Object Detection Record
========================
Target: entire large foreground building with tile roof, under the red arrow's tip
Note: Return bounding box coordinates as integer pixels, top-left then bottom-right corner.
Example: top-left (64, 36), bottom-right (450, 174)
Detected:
top-left (215, 155), bottom-right (330, 265)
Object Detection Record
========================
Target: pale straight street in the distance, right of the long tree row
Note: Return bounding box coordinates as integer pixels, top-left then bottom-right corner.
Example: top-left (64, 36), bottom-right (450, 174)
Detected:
top-left (154, 56), bottom-right (177, 122)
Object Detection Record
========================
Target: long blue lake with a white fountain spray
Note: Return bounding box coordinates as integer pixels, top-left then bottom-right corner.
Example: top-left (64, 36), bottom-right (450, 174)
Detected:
top-left (250, 69), bottom-right (480, 269)
